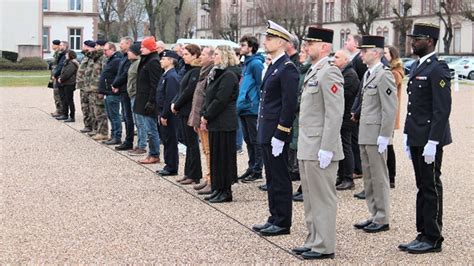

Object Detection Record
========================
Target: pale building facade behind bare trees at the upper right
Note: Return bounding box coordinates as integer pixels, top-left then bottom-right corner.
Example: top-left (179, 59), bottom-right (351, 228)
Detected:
top-left (196, 0), bottom-right (474, 54)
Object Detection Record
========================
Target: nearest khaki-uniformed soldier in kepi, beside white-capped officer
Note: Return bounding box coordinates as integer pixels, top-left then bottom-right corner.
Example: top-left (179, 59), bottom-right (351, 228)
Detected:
top-left (292, 27), bottom-right (344, 259)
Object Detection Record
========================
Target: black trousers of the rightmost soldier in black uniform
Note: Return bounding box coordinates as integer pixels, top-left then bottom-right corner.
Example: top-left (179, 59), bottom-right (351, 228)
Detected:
top-left (410, 144), bottom-right (444, 246)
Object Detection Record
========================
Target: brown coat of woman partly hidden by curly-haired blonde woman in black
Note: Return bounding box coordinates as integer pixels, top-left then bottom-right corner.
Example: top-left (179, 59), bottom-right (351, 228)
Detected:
top-left (188, 63), bottom-right (214, 127)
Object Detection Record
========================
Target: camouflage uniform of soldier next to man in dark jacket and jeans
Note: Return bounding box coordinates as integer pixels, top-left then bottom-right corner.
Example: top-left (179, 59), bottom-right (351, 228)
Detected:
top-left (84, 50), bottom-right (109, 135)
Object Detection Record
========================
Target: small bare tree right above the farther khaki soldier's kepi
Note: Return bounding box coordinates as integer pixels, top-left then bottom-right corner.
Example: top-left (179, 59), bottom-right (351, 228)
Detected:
top-left (348, 0), bottom-right (383, 35)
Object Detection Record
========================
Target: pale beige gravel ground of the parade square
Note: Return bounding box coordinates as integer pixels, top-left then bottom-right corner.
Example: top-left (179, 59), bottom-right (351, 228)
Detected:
top-left (0, 85), bottom-right (474, 264)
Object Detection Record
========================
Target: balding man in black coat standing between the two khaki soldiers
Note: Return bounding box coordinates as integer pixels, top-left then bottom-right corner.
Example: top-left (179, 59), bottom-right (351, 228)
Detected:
top-left (333, 49), bottom-right (360, 190)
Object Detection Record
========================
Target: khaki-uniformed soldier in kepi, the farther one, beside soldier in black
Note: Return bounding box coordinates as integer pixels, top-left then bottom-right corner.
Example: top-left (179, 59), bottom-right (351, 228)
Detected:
top-left (354, 36), bottom-right (397, 233)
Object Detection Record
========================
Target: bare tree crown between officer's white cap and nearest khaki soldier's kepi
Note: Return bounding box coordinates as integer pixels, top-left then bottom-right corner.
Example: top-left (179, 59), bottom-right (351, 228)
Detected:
top-left (258, 0), bottom-right (314, 39)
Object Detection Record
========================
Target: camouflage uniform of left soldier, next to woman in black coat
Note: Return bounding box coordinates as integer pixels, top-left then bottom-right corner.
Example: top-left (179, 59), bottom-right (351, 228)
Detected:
top-left (76, 52), bottom-right (94, 130)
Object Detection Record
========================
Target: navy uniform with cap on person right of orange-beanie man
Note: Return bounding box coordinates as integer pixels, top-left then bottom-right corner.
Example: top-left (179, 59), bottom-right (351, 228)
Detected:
top-left (156, 50), bottom-right (179, 174)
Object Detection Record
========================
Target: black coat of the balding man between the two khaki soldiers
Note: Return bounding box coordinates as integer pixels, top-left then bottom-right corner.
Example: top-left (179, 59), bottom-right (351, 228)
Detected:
top-left (342, 63), bottom-right (360, 127)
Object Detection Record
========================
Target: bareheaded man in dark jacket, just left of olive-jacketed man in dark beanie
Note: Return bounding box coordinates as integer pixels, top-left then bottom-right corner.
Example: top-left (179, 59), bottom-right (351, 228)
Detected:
top-left (112, 36), bottom-right (135, 151)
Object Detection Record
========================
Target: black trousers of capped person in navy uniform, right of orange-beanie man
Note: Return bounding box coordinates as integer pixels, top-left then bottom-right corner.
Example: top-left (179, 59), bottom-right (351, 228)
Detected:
top-left (159, 115), bottom-right (179, 173)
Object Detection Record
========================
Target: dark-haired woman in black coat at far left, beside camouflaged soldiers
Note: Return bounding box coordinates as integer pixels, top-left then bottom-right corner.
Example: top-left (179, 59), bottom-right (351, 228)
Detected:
top-left (56, 50), bottom-right (79, 122)
